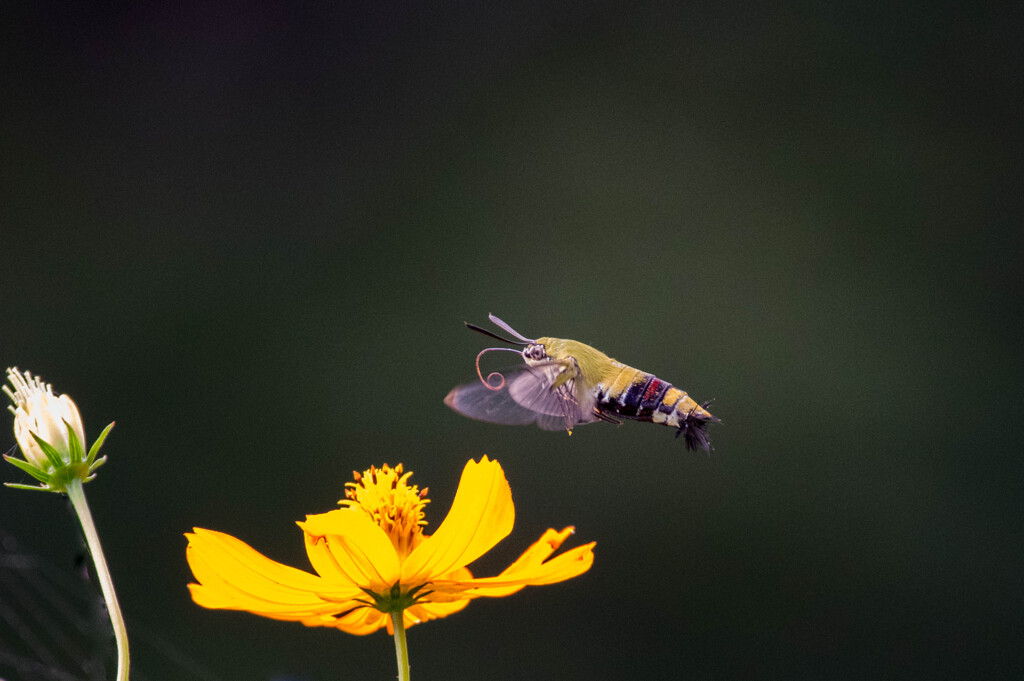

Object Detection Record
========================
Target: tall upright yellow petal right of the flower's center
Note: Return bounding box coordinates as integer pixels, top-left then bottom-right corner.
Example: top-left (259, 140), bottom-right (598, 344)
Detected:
top-left (401, 456), bottom-right (515, 586)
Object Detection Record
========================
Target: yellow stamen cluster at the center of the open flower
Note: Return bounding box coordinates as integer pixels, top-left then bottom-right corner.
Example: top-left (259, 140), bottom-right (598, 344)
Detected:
top-left (338, 464), bottom-right (430, 559)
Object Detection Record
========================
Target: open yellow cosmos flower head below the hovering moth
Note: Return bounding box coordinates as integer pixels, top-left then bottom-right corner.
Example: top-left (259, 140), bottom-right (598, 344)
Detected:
top-left (185, 457), bottom-right (594, 634)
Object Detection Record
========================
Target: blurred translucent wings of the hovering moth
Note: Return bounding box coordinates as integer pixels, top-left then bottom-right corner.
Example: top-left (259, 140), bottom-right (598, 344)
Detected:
top-left (444, 363), bottom-right (596, 430)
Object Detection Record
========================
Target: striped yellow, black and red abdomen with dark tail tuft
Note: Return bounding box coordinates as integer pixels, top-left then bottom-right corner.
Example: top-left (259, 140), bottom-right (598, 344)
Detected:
top-left (597, 363), bottom-right (718, 450)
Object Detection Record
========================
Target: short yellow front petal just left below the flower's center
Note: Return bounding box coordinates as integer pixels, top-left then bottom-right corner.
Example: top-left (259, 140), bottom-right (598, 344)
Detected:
top-left (298, 508), bottom-right (401, 593)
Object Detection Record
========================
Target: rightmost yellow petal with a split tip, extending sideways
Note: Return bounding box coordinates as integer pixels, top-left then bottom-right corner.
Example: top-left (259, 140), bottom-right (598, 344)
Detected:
top-left (431, 527), bottom-right (595, 598)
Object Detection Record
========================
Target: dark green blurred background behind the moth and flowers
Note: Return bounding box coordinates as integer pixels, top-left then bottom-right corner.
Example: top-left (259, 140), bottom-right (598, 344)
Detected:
top-left (0, 2), bottom-right (1024, 681)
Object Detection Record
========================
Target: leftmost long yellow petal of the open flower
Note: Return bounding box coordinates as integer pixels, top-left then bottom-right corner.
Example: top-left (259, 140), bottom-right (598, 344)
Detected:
top-left (185, 527), bottom-right (364, 620)
